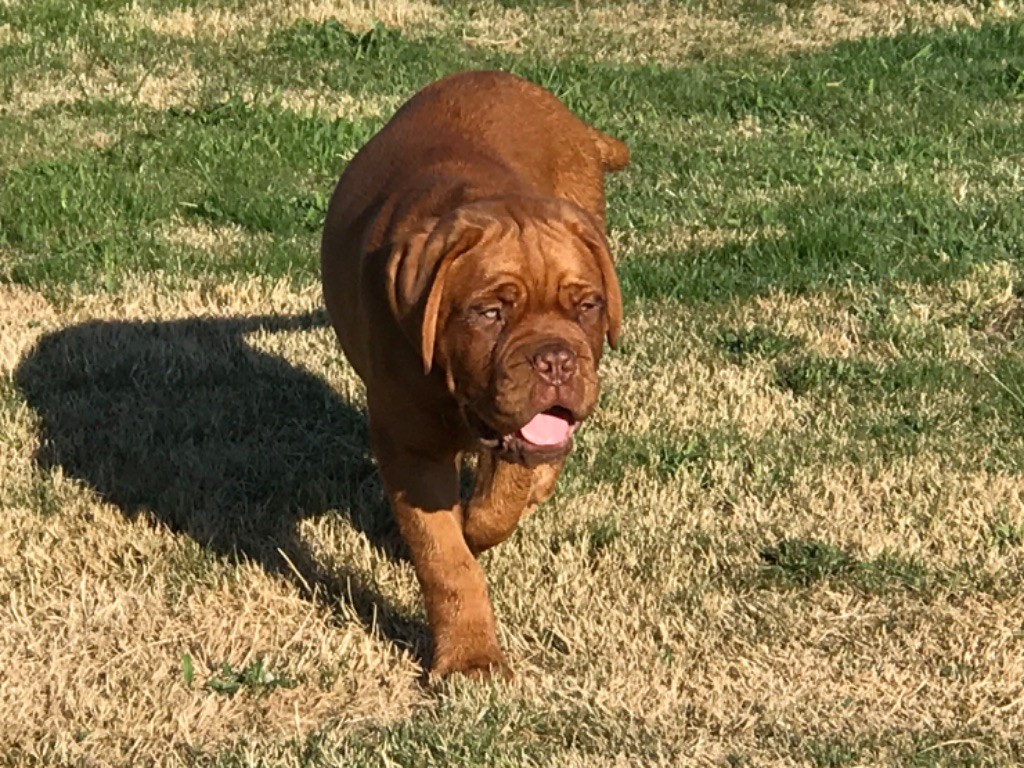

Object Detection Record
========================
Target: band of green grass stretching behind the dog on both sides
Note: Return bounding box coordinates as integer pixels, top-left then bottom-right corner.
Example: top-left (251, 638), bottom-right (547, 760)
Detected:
top-left (0, 16), bottom-right (1024, 301)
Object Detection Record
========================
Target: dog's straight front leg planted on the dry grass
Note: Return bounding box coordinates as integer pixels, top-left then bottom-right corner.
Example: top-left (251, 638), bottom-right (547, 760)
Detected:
top-left (374, 439), bottom-right (511, 678)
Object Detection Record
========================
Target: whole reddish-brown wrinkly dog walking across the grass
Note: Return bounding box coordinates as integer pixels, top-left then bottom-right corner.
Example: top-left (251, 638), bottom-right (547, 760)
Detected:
top-left (321, 72), bottom-right (629, 677)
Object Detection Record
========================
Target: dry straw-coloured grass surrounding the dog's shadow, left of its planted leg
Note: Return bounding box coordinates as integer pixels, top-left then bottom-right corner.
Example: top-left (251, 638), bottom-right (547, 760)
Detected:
top-left (0, 284), bottom-right (422, 762)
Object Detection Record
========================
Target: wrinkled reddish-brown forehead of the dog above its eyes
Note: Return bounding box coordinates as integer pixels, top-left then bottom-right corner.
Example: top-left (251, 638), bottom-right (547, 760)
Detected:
top-left (453, 221), bottom-right (601, 293)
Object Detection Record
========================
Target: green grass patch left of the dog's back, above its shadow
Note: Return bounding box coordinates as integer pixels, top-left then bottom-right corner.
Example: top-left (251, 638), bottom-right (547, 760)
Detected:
top-left (0, 100), bottom-right (372, 287)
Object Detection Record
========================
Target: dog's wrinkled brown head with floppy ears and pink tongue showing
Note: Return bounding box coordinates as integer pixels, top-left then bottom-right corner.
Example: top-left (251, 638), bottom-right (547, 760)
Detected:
top-left (389, 198), bottom-right (623, 465)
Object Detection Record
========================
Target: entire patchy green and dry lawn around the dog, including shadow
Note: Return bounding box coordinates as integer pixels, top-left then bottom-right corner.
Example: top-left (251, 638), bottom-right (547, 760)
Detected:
top-left (0, 0), bottom-right (1024, 766)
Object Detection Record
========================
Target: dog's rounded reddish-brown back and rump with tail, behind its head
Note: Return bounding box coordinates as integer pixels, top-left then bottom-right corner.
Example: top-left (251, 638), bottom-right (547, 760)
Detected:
top-left (328, 72), bottom-right (629, 250)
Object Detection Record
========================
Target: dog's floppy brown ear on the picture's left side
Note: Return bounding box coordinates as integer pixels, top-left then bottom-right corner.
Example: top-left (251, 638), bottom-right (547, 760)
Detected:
top-left (387, 208), bottom-right (495, 374)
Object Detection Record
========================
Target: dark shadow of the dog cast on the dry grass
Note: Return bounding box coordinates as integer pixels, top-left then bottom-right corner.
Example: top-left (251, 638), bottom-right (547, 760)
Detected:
top-left (16, 312), bottom-right (428, 660)
